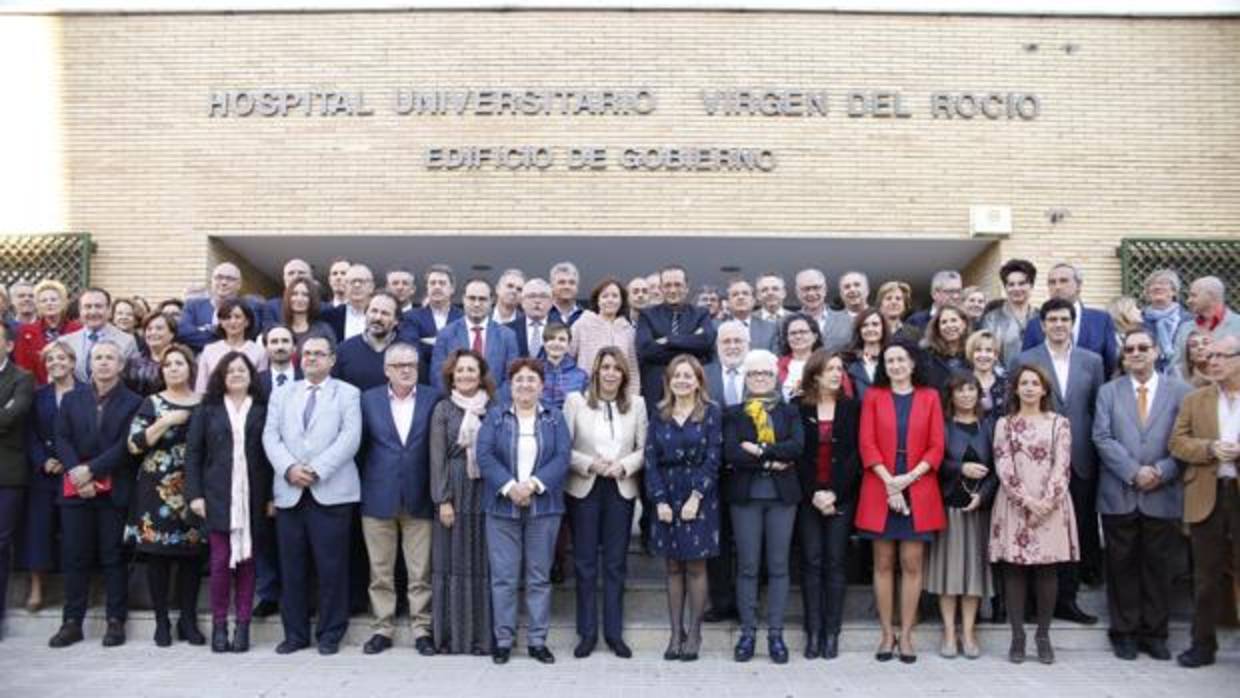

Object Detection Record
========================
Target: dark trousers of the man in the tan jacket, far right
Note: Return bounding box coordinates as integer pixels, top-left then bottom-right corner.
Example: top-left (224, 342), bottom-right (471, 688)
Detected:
top-left (1189, 480), bottom-right (1240, 652)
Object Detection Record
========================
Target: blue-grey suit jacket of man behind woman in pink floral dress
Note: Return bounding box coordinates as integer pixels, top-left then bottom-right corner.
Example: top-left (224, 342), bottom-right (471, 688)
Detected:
top-left (1008, 344), bottom-right (1106, 480)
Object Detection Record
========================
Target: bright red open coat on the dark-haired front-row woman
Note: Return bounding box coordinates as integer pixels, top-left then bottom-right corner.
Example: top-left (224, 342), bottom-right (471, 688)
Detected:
top-left (857, 387), bottom-right (947, 533)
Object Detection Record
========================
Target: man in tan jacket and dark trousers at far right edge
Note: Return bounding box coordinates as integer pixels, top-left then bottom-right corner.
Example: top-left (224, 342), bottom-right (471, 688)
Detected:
top-left (1171, 337), bottom-right (1240, 668)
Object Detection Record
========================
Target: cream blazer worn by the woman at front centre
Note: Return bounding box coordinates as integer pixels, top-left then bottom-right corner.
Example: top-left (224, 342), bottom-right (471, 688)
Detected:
top-left (564, 393), bottom-right (647, 500)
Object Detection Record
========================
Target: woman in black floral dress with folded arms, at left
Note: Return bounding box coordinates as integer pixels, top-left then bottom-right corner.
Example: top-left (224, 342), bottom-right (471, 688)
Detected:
top-left (125, 345), bottom-right (207, 647)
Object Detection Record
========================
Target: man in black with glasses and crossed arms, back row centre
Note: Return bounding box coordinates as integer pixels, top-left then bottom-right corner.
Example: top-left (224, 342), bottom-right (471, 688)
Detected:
top-left (637, 265), bottom-right (714, 412)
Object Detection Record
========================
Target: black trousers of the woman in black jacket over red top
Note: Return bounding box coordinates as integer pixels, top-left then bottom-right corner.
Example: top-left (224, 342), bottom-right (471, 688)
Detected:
top-left (797, 503), bottom-right (853, 636)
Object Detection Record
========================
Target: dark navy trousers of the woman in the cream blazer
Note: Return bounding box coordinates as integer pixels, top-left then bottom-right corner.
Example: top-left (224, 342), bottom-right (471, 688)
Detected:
top-left (564, 477), bottom-right (634, 641)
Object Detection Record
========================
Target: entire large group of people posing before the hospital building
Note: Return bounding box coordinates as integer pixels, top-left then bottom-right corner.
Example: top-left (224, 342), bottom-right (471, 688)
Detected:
top-left (0, 259), bottom-right (1240, 667)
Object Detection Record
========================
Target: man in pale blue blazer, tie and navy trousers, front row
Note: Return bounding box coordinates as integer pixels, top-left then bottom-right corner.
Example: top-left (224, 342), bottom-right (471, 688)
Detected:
top-left (263, 336), bottom-right (362, 655)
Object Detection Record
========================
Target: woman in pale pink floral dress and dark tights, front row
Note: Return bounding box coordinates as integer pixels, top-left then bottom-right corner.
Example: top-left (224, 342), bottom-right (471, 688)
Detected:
top-left (990, 366), bottom-right (1080, 665)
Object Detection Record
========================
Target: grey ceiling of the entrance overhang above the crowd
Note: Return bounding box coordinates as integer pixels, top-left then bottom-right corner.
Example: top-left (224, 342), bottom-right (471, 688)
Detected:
top-left (218, 234), bottom-right (990, 298)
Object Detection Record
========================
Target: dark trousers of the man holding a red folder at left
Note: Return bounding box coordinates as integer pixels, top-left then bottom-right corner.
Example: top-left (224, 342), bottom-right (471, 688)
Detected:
top-left (61, 497), bottom-right (129, 624)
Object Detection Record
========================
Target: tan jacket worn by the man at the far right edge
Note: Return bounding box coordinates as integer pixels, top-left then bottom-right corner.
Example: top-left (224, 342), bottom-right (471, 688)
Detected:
top-left (1171, 384), bottom-right (1240, 523)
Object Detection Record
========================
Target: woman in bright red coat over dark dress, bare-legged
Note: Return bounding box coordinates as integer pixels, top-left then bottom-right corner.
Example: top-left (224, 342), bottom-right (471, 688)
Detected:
top-left (856, 340), bottom-right (946, 663)
